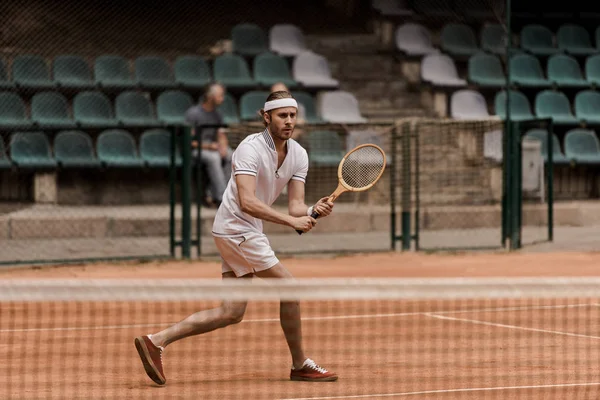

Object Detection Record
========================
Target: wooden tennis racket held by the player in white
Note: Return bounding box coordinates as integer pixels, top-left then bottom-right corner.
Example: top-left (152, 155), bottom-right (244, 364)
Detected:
top-left (296, 144), bottom-right (386, 235)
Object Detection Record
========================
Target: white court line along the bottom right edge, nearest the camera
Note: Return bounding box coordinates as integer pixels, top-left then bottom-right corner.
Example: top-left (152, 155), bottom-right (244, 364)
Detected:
top-left (279, 382), bottom-right (600, 400)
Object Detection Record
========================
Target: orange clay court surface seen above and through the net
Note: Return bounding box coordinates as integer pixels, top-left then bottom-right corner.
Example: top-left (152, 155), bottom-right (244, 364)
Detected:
top-left (0, 252), bottom-right (600, 400)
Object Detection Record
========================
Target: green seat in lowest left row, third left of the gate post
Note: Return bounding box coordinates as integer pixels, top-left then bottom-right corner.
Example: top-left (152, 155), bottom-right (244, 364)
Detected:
top-left (54, 131), bottom-right (102, 168)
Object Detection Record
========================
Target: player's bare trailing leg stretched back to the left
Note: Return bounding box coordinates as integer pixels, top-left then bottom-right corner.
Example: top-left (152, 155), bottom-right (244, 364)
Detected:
top-left (151, 272), bottom-right (252, 347)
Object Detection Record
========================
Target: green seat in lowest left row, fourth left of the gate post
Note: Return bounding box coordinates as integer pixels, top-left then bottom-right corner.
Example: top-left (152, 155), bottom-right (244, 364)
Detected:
top-left (10, 132), bottom-right (57, 168)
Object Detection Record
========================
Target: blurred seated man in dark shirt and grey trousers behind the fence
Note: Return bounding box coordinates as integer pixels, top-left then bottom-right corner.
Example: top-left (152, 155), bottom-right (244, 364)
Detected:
top-left (185, 83), bottom-right (233, 207)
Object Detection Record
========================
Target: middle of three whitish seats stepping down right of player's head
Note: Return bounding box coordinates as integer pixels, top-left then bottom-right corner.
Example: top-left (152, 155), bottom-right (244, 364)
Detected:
top-left (292, 51), bottom-right (340, 89)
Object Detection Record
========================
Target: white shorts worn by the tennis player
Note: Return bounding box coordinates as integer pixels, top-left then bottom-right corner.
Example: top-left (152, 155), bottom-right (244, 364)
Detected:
top-left (213, 232), bottom-right (279, 277)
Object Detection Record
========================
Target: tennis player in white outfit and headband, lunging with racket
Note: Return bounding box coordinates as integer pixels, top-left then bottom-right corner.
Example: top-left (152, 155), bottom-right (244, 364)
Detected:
top-left (135, 91), bottom-right (338, 385)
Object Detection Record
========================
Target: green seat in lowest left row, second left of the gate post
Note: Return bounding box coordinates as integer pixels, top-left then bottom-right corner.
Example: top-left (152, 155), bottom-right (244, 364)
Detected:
top-left (96, 129), bottom-right (144, 168)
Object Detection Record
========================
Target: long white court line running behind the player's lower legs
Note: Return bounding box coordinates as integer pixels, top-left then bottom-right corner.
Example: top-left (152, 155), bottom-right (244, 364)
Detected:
top-left (0, 303), bottom-right (600, 333)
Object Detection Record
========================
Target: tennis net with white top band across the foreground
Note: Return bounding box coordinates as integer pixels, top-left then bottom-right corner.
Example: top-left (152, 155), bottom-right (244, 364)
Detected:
top-left (0, 278), bottom-right (600, 400)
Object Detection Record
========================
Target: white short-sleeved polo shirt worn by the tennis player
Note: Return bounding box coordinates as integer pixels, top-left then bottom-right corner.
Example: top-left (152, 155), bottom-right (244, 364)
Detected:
top-left (212, 129), bottom-right (308, 236)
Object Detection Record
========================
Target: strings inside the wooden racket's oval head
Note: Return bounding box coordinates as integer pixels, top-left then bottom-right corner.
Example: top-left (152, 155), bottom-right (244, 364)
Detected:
top-left (341, 146), bottom-right (385, 189)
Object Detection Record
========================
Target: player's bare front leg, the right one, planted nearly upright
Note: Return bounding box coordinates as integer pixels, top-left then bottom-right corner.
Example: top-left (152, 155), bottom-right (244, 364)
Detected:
top-left (256, 263), bottom-right (306, 368)
